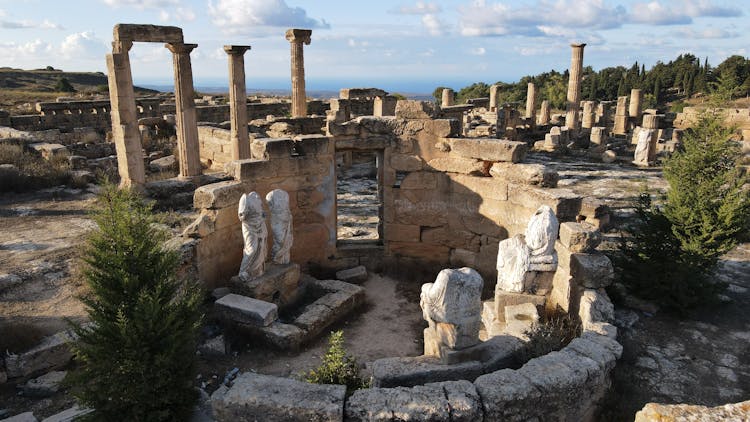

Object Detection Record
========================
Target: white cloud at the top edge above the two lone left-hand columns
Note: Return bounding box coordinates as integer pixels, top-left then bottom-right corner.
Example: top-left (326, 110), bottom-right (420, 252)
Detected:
top-left (208, 0), bottom-right (330, 33)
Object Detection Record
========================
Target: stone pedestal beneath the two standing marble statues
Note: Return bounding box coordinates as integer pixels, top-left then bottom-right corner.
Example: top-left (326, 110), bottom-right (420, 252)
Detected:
top-left (229, 263), bottom-right (300, 307)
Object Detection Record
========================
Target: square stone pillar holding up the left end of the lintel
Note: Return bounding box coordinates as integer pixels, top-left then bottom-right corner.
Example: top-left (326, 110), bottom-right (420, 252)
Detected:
top-left (107, 41), bottom-right (146, 189)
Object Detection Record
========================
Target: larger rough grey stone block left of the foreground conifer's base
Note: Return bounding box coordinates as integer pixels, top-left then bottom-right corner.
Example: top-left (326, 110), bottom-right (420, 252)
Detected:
top-left (5, 331), bottom-right (75, 378)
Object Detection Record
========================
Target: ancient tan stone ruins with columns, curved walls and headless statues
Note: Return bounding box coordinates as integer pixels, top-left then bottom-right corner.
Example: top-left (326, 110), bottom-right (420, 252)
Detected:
top-left (0, 24), bottom-right (747, 421)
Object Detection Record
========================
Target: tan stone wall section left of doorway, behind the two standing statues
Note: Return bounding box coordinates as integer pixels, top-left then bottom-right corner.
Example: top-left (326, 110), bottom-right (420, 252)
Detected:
top-left (185, 135), bottom-right (336, 287)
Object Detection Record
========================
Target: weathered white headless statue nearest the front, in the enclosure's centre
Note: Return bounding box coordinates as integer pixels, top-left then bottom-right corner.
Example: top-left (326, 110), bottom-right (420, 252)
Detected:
top-left (419, 267), bottom-right (484, 349)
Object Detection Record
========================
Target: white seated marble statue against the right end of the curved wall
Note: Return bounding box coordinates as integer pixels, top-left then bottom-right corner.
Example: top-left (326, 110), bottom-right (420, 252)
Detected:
top-left (495, 205), bottom-right (560, 293)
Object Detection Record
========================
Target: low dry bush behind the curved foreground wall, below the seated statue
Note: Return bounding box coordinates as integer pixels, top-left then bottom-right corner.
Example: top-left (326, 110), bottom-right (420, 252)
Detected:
top-left (520, 312), bottom-right (581, 362)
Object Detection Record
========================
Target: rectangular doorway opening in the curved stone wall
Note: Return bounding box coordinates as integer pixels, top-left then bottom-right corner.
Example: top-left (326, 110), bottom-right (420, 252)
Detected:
top-left (336, 150), bottom-right (383, 244)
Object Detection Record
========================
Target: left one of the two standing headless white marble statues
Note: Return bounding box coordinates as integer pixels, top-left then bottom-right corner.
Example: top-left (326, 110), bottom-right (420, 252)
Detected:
top-left (237, 192), bottom-right (268, 281)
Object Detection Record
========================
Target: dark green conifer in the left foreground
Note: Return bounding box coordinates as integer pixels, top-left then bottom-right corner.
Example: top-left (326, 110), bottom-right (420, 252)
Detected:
top-left (72, 185), bottom-right (202, 421)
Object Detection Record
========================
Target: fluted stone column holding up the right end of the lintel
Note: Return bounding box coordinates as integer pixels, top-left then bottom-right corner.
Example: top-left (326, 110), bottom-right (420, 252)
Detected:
top-left (166, 44), bottom-right (201, 178)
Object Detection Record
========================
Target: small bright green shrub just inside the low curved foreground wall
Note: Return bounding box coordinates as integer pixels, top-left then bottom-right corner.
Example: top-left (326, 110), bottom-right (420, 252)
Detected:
top-left (305, 331), bottom-right (370, 395)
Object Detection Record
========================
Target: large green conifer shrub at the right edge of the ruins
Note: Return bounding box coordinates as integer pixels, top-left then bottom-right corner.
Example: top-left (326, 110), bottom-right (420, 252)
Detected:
top-left (611, 110), bottom-right (750, 312)
